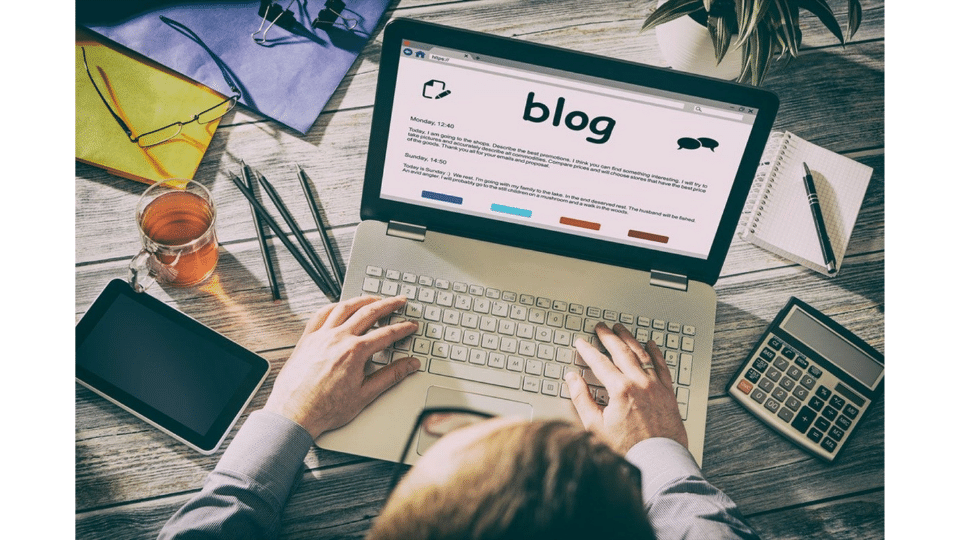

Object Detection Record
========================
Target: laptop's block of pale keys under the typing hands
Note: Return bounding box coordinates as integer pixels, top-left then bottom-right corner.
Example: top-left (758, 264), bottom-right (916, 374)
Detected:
top-left (362, 266), bottom-right (696, 420)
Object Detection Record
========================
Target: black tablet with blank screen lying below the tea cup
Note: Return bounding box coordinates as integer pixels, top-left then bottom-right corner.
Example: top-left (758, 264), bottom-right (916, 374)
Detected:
top-left (76, 279), bottom-right (270, 454)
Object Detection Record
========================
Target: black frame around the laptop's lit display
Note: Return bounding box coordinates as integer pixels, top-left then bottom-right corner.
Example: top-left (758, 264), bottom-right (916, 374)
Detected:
top-left (360, 18), bottom-right (779, 286)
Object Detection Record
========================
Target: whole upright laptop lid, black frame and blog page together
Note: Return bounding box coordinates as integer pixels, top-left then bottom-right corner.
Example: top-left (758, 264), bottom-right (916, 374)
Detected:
top-left (360, 18), bottom-right (779, 284)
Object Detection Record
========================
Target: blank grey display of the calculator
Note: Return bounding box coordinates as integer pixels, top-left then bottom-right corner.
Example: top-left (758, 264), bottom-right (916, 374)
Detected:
top-left (780, 307), bottom-right (883, 390)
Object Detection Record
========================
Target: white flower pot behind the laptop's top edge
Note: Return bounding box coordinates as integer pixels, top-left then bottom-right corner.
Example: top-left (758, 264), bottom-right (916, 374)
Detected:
top-left (655, 0), bottom-right (742, 81)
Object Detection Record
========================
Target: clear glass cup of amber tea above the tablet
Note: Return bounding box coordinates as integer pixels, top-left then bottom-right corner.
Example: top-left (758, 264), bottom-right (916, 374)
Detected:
top-left (130, 178), bottom-right (219, 292)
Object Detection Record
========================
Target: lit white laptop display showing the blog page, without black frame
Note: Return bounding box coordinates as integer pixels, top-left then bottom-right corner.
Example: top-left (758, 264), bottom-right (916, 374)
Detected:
top-left (380, 40), bottom-right (757, 259)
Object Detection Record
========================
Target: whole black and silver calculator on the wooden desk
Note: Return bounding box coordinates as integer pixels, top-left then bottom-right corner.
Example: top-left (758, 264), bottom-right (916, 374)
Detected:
top-left (727, 297), bottom-right (884, 462)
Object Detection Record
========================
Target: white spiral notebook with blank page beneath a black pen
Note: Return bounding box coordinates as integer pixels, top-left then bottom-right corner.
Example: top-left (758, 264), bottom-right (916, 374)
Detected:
top-left (739, 131), bottom-right (873, 277)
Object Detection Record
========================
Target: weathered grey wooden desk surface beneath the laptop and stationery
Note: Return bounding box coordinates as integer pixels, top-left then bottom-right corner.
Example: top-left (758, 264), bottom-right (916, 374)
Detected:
top-left (76, 0), bottom-right (884, 539)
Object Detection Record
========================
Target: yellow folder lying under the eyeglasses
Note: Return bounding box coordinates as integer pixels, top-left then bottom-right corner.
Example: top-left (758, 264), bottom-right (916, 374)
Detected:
top-left (76, 28), bottom-right (225, 183)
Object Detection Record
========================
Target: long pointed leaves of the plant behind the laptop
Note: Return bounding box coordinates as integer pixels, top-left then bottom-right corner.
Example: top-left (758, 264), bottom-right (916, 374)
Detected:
top-left (640, 0), bottom-right (863, 85)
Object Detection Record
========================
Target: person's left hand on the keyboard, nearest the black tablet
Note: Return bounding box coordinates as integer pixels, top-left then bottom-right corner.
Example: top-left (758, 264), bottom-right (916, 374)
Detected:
top-left (264, 296), bottom-right (420, 439)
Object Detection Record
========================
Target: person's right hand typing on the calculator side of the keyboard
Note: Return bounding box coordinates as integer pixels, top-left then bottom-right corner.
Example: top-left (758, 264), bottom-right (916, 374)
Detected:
top-left (565, 323), bottom-right (687, 454)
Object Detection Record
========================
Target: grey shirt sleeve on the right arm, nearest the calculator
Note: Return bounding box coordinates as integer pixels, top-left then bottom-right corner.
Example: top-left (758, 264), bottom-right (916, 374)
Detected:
top-left (626, 438), bottom-right (760, 540)
